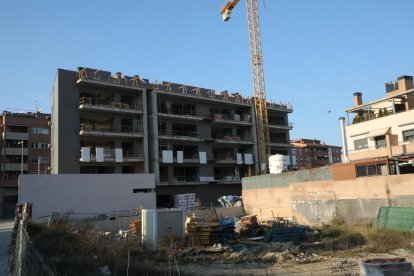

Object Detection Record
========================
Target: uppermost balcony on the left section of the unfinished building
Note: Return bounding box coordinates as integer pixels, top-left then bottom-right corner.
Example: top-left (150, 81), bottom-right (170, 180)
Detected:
top-left (79, 97), bottom-right (143, 115)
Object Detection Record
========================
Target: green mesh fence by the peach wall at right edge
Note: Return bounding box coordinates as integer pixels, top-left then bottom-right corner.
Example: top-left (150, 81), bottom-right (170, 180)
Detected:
top-left (375, 207), bottom-right (414, 233)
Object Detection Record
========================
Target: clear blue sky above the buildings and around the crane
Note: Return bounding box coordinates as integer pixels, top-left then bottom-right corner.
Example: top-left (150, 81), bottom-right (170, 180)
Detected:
top-left (0, 0), bottom-right (414, 145)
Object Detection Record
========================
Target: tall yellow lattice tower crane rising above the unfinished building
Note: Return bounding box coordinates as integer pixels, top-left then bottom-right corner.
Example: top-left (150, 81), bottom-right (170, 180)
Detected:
top-left (220, 0), bottom-right (270, 174)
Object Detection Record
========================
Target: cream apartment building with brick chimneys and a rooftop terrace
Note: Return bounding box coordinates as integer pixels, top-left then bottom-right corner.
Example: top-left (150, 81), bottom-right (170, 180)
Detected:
top-left (341, 76), bottom-right (414, 177)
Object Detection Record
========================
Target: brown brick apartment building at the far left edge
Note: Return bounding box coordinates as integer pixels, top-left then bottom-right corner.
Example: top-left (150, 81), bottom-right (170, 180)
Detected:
top-left (0, 111), bottom-right (50, 218)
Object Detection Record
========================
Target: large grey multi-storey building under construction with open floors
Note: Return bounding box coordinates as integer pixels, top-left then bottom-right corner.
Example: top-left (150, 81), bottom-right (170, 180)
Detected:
top-left (51, 68), bottom-right (292, 207)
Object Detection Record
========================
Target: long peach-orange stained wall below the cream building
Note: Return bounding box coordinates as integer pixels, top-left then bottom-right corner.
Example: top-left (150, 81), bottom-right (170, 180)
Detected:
top-left (242, 174), bottom-right (414, 225)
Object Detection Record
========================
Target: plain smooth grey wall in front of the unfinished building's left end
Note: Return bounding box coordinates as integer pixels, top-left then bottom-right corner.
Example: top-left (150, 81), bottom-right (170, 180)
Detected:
top-left (19, 174), bottom-right (156, 219)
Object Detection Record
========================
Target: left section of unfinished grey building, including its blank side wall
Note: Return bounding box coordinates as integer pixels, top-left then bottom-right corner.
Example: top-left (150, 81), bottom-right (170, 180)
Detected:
top-left (51, 68), bottom-right (149, 174)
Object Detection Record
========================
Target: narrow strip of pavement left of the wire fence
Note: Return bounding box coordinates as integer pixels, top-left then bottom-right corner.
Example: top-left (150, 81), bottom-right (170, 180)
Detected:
top-left (0, 219), bottom-right (14, 275)
